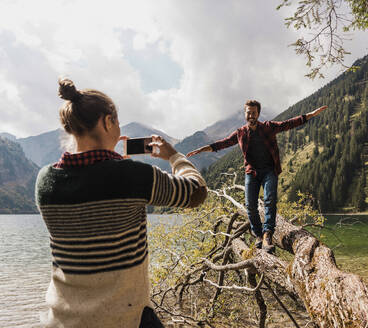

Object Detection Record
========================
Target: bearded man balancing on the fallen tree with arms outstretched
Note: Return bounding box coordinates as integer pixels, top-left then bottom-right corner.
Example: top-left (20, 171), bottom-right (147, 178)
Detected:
top-left (187, 100), bottom-right (327, 252)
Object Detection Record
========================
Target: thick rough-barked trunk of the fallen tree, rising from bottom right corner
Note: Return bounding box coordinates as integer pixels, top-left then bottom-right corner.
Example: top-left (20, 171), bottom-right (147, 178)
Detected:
top-left (274, 210), bottom-right (368, 328)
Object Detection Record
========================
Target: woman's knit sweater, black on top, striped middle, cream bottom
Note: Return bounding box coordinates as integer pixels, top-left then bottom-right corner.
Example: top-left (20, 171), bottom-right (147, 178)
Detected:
top-left (36, 153), bottom-right (206, 328)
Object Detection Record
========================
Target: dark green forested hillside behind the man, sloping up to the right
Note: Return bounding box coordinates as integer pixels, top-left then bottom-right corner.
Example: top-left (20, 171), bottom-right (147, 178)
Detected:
top-left (204, 56), bottom-right (368, 211)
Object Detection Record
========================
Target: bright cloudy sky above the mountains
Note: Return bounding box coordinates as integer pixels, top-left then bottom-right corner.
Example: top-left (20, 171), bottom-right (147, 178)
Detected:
top-left (0, 0), bottom-right (368, 138)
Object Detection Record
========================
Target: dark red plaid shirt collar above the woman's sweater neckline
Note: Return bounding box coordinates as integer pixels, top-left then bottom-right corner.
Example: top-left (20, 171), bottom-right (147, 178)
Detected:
top-left (53, 149), bottom-right (123, 169)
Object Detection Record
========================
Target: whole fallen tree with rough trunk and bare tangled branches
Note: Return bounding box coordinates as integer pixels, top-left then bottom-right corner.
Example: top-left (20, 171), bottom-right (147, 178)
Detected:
top-left (150, 181), bottom-right (368, 328)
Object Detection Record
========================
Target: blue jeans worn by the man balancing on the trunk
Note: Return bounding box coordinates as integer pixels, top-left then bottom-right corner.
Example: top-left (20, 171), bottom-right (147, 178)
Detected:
top-left (245, 169), bottom-right (278, 237)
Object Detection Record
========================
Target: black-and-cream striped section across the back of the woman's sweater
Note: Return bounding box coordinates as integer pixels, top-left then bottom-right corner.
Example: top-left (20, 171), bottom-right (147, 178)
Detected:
top-left (40, 199), bottom-right (147, 274)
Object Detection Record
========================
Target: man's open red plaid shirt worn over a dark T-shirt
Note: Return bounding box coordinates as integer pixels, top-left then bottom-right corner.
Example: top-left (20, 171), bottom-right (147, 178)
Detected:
top-left (210, 115), bottom-right (307, 175)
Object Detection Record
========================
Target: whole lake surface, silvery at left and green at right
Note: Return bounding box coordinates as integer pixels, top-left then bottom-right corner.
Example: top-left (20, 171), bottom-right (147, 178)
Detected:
top-left (0, 214), bottom-right (368, 328)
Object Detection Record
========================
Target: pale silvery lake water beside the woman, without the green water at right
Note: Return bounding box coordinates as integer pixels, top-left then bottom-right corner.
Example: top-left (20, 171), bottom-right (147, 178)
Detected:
top-left (0, 214), bottom-right (178, 328)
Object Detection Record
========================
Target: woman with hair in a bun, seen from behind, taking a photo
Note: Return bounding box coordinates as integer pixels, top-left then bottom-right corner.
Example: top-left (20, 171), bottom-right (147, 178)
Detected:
top-left (36, 79), bottom-right (207, 328)
